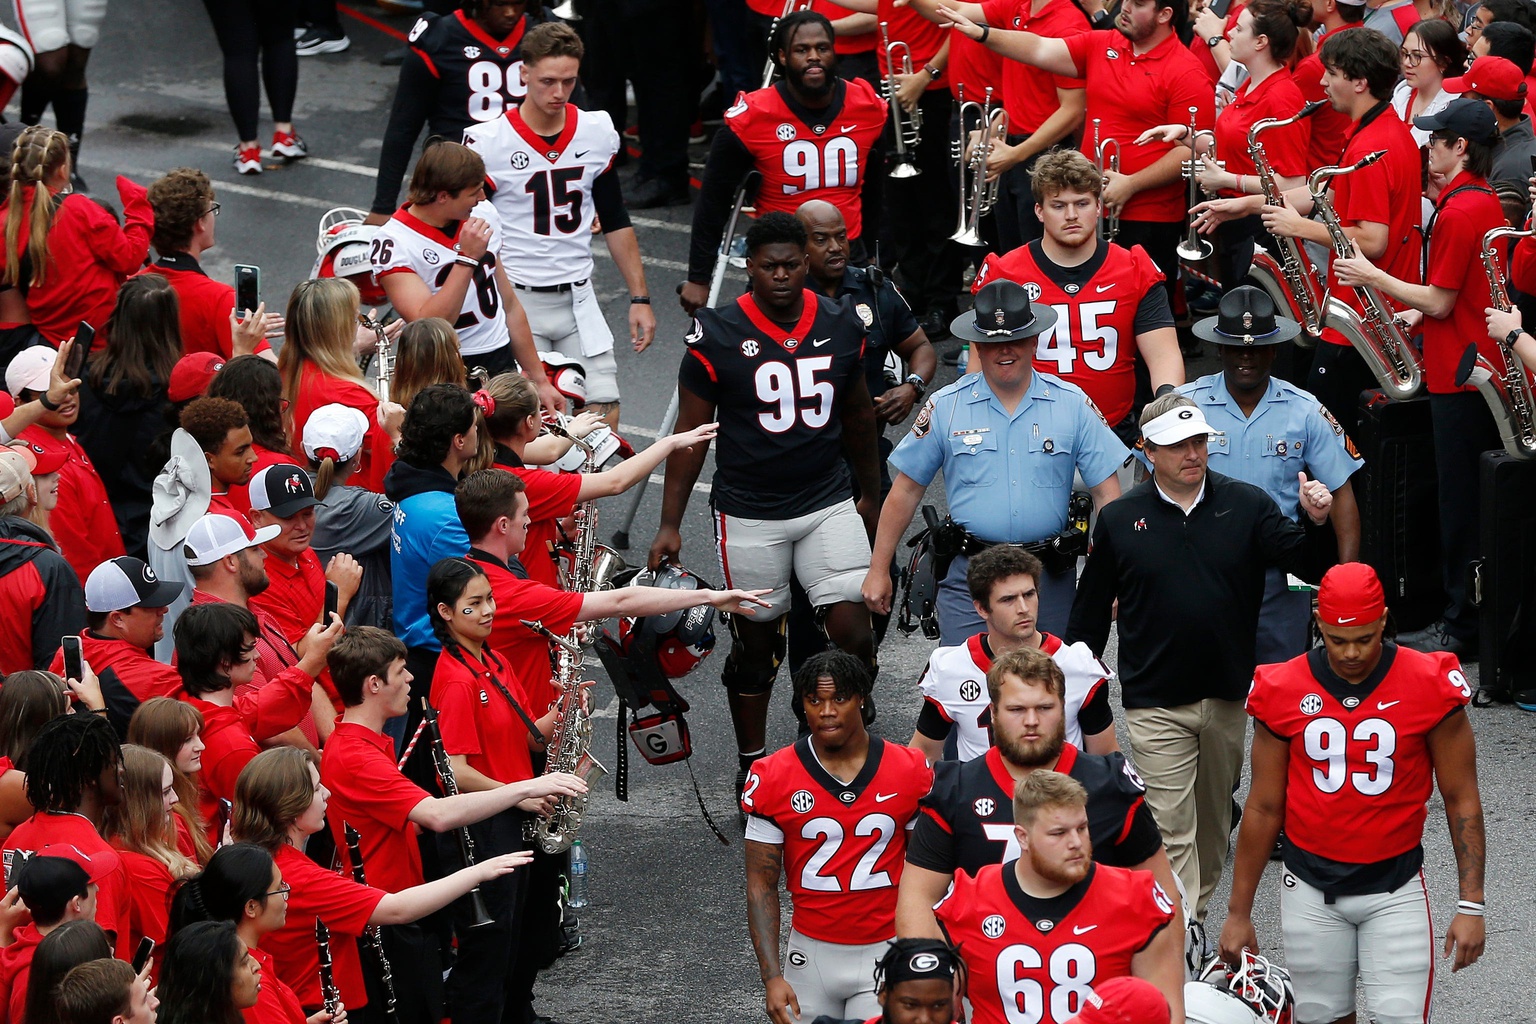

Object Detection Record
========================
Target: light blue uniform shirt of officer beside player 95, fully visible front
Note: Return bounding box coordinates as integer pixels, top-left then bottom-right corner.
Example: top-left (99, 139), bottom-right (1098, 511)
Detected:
top-left (891, 372), bottom-right (1130, 543)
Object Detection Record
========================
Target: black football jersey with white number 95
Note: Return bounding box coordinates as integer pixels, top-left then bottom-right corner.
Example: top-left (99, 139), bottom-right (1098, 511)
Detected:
top-left (677, 290), bottom-right (865, 519)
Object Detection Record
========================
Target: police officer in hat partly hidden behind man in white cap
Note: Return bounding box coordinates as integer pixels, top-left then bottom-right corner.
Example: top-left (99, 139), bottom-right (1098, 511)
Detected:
top-left (1178, 286), bottom-right (1361, 665)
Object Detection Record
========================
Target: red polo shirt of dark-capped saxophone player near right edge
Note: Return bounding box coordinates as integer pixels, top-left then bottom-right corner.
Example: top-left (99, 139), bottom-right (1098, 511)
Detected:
top-left (1424, 170), bottom-right (1504, 395)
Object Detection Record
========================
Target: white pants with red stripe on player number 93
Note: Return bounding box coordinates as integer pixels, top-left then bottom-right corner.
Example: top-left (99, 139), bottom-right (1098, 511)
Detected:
top-left (1279, 870), bottom-right (1435, 1024)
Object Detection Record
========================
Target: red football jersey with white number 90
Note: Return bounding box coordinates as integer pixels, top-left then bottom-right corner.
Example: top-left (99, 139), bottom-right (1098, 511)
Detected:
top-left (725, 78), bottom-right (886, 238)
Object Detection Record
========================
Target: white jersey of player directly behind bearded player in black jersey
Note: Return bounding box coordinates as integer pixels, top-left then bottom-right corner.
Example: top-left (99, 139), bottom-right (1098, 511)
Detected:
top-left (919, 633), bottom-right (1114, 761)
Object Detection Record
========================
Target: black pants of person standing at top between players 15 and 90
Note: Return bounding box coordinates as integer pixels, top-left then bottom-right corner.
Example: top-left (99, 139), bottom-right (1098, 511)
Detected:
top-left (581, 0), bottom-right (697, 189)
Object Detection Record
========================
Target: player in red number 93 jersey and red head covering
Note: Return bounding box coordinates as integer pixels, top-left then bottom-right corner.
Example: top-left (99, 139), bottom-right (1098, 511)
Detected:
top-left (1221, 562), bottom-right (1484, 1024)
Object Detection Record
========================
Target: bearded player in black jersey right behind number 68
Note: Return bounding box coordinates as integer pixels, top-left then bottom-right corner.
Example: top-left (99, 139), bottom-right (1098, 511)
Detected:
top-left (897, 648), bottom-right (1178, 936)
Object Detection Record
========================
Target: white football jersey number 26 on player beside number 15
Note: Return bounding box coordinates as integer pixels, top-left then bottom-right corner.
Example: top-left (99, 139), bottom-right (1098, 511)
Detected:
top-left (369, 201), bottom-right (511, 356)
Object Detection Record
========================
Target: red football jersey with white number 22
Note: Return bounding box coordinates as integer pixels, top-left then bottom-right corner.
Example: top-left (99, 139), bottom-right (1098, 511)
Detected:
top-left (742, 737), bottom-right (934, 946)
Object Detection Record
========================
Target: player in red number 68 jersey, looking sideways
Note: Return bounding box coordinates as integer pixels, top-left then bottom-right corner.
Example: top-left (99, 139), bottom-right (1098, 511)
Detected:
top-left (935, 771), bottom-right (1184, 1024)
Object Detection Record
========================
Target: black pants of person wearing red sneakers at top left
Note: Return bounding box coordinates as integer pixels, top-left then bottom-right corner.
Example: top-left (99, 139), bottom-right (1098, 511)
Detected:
top-left (203, 0), bottom-right (298, 141)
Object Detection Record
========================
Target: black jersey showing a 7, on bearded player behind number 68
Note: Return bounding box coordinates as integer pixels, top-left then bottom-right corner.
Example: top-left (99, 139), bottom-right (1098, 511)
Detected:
top-left (906, 743), bottom-right (1163, 875)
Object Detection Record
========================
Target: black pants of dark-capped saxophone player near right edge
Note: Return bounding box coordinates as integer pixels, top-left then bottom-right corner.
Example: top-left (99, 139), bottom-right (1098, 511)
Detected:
top-left (1430, 391), bottom-right (1499, 643)
